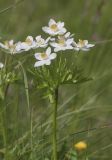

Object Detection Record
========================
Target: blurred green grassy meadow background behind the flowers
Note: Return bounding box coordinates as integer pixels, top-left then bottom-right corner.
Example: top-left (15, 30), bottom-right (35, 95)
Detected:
top-left (0, 0), bottom-right (112, 160)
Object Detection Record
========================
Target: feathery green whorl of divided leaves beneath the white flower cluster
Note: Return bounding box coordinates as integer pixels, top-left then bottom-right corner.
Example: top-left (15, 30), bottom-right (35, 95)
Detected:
top-left (29, 57), bottom-right (92, 102)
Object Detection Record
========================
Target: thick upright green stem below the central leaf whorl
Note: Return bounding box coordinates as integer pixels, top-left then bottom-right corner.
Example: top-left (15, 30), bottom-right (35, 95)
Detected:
top-left (53, 89), bottom-right (58, 160)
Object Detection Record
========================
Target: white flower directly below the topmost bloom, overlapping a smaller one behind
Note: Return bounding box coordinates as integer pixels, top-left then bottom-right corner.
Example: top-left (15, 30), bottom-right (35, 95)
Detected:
top-left (50, 32), bottom-right (74, 52)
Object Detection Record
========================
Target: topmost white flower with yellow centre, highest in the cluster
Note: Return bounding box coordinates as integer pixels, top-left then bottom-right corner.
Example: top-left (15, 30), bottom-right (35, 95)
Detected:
top-left (42, 19), bottom-right (66, 36)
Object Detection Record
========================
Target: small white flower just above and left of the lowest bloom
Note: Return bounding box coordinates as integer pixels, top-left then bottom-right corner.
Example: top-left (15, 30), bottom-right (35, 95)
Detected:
top-left (34, 35), bottom-right (50, 48)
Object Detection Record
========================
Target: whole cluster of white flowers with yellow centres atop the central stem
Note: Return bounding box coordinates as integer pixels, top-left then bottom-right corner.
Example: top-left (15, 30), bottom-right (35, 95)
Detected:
top-left (0, 19), bottom-right (94, 67)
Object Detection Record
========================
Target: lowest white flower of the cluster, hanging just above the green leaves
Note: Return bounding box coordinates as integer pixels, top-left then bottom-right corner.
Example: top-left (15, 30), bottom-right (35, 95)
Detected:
top-left (34, 47), bottom-right (56, 67)
